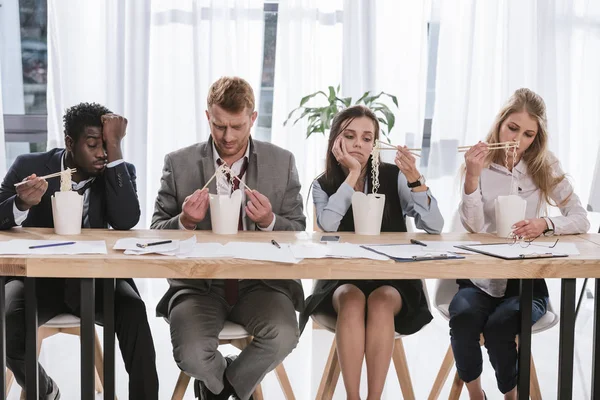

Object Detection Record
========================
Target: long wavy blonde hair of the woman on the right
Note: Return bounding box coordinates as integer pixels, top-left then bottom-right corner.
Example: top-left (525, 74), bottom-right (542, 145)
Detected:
top-left (485, 88), bottom-right (571, 206)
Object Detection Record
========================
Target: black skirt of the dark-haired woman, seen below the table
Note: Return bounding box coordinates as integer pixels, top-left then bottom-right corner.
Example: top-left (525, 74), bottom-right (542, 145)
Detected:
top-left (300, 279), bottom-right (433, 335)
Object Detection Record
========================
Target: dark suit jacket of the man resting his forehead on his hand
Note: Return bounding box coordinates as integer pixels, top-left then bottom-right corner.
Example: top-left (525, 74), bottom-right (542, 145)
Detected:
top-left (0, 149), bottom-right (140, 306)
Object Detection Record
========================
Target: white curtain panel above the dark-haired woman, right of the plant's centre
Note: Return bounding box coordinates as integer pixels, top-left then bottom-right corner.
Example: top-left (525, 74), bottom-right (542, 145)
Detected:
top-left (342, 0), bottom-right (431, 153)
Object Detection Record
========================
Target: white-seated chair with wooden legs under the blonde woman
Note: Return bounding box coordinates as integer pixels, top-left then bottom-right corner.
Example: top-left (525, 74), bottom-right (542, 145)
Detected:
top-left (428, 279), bottom-right (558, 400)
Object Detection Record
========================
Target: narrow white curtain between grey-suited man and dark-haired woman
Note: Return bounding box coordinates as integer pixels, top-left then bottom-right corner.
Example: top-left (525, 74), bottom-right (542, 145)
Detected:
top-left (271, 0), bottom-right (342, 230)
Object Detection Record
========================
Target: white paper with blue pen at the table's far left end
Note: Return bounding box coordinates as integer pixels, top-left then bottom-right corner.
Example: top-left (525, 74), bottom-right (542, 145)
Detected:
top-left (0, 239), bottom-right (106, 255)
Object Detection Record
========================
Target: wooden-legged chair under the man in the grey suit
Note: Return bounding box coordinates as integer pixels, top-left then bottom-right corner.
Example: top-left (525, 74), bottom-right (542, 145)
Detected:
top-left (171, 321), bottom-right (296, 400)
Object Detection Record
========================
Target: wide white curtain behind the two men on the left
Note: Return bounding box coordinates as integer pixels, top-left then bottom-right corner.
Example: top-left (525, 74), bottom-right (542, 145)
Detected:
top-left (48, 0), bottom-right (264, 227)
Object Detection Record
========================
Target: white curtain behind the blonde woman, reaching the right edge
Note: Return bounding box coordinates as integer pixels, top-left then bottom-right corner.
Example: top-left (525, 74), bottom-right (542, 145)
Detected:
top-left (428, 0), bottom-right (600, 230)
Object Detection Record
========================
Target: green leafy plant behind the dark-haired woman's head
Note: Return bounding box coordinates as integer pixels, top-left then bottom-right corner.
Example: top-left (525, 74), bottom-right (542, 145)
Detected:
top-left (283, 85), bottom-right (398, 142)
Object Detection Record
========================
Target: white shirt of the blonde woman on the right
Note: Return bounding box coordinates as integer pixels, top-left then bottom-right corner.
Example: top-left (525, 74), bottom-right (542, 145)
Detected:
top-left (459, 153), bottom-right (590, 297)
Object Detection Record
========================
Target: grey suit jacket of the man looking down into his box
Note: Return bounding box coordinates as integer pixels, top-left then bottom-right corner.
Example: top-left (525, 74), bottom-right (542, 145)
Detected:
top-left (150, 139), bottom-right (306, 317)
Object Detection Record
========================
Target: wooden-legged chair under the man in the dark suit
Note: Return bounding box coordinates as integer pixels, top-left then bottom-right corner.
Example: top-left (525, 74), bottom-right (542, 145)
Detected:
top-left (6, 314), bottom-right (107, 399)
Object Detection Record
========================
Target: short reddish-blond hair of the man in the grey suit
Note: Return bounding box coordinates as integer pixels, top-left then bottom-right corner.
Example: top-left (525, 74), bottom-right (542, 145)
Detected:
top-left (206, 76), bottom-right (255, 114)
